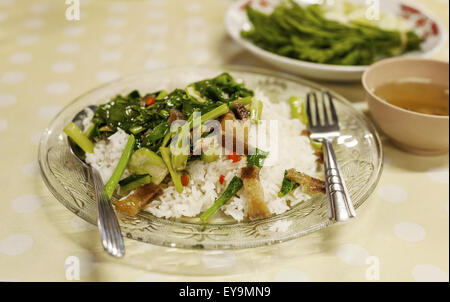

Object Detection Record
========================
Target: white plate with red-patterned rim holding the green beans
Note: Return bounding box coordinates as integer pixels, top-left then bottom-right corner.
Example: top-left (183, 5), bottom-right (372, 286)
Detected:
top-left (225, 0), bottom-right (445, 82)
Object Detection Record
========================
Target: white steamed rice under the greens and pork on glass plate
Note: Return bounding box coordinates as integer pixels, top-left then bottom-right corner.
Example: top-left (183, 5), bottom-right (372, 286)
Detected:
top-left (86, 91), bottom-right (318, 221)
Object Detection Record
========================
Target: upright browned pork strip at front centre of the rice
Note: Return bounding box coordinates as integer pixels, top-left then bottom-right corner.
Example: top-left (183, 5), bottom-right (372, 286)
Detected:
top-left (241, 166), bottom-right (270, 220)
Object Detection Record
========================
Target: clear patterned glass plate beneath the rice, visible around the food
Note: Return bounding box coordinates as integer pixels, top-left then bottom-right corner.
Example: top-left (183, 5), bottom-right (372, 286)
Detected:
top-left (38, 67), bottom-right (383, 249)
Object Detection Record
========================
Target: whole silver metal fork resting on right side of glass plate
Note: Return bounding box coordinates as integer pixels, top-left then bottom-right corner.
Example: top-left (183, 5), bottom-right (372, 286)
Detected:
top-left (306, 90), bottom-right (356, 222)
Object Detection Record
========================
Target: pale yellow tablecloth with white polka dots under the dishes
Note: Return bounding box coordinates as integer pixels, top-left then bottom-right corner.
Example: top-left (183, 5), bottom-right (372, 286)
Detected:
top-left (0, 0), bottom-right (449, 281)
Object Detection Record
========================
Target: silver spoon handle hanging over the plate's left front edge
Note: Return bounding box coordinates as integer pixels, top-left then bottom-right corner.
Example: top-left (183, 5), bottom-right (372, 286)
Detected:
top-left (91, 168), bottom-right (125, 258)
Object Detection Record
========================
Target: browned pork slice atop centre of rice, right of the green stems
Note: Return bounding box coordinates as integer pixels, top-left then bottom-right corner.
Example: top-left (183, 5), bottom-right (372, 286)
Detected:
top-left (220, 111), bottom-right (249, 154)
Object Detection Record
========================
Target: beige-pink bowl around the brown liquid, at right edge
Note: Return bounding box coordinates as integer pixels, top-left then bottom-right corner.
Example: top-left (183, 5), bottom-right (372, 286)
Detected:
top-left (362, 58), bottom-right (449, 156)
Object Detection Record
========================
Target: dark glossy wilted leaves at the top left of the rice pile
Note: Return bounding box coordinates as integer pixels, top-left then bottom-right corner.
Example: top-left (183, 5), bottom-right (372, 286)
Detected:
top-left (90, 73), bottom-right (253, 152)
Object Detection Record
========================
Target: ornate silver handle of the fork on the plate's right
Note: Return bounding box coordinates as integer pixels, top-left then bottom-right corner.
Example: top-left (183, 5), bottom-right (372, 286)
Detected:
top-left (322, 139), bottom-right (356, 222)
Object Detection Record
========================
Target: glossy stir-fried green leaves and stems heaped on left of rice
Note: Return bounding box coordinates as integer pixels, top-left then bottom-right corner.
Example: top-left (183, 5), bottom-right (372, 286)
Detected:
top-left (65, 73), bottom-right (261, 196)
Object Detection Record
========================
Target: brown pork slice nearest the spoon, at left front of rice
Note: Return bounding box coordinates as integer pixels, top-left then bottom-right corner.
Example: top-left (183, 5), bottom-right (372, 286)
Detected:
top-left (116, 183), bottom-right (163, 216)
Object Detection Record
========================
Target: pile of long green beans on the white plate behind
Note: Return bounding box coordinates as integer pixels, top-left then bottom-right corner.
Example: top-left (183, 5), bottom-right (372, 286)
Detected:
top-left (241, 0), bottom-right (422, 65)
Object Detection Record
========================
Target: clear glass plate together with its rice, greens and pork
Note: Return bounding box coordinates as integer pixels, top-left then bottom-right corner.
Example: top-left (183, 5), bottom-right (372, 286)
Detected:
top-left (39, 67), bottom-right (382, 249)
